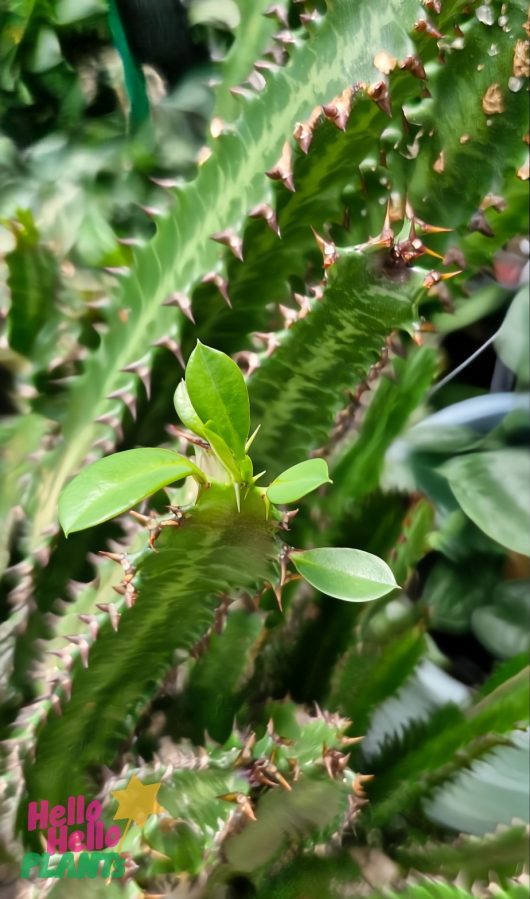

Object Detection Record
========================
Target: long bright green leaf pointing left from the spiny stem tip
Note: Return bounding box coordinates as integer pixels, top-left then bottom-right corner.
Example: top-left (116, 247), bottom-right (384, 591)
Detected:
top-left (59, 449), bottom-right (204, 536)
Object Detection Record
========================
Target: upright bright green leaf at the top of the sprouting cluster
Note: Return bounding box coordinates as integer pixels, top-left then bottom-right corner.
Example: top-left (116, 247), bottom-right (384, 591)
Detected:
top-left (186, 341), bottom-right (250, 459)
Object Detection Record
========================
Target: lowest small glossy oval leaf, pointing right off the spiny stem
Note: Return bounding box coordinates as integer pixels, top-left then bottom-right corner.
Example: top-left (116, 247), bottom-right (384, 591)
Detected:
top-left (291, 547), bottom-right (398, 602)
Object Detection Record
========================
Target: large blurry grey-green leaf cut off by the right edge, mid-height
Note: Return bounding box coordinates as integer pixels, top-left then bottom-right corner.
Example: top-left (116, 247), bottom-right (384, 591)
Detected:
top-left (441, 448), bottom-right (530, 556)
